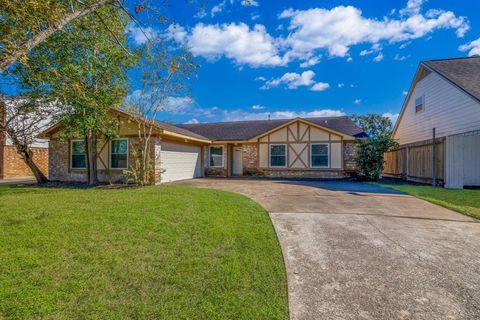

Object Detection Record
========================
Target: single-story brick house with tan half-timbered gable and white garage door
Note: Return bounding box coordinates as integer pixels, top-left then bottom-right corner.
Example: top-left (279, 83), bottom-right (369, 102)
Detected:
top-left (41, 110), bottom-right (365, 183)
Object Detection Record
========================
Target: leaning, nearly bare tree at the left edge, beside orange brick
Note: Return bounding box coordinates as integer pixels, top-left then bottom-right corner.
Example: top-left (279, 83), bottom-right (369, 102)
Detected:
top-left (0, 96), bottom-right (60, 183)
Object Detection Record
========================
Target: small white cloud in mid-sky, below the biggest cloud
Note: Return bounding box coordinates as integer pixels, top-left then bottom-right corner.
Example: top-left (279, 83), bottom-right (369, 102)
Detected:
top-left (260, 70), bottom-right (330, 91)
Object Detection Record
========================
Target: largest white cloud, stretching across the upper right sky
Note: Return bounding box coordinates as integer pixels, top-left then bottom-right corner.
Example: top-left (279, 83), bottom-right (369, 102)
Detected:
top-left (280, 1), bottom-right (469, 57)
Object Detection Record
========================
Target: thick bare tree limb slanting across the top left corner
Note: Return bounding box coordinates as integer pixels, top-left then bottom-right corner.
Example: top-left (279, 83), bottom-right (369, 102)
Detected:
top-left (0, 0), bottom-right (114, 72)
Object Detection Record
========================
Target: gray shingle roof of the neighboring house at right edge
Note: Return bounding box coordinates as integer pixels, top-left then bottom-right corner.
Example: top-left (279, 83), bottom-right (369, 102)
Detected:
top-left (423, 57), bottom-right (480, 101)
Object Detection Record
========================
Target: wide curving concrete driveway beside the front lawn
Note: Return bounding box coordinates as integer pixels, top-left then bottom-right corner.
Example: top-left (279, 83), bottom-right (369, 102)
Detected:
top-left (176, 179), bottom-right (480, 319)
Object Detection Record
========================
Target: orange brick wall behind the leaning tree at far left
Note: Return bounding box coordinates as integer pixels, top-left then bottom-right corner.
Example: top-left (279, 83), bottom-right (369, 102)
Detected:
top-left (2, 146), bottom-right (48, 178)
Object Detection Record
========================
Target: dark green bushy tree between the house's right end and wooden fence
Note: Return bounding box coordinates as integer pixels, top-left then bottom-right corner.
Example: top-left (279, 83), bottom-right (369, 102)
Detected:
top-left (353, 114), bottom-right (398, 181)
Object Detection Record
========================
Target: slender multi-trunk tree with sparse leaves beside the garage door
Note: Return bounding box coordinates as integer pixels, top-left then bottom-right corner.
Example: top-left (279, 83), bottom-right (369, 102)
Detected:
top-left (124, 37), bottom-right (197, 185)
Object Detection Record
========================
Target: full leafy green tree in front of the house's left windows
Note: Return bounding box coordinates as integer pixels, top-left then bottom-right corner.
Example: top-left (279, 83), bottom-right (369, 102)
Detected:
top-left (13, 6), bottom-right (137, 185)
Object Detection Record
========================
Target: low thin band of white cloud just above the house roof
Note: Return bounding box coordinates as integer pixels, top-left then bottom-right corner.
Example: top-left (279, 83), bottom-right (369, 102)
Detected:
top-left (222, 109), bottom-right (345, 121)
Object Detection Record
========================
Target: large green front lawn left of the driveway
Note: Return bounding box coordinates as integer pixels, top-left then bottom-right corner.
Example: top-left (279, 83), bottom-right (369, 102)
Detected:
top-left (0, 186), bottom-right (288, 319)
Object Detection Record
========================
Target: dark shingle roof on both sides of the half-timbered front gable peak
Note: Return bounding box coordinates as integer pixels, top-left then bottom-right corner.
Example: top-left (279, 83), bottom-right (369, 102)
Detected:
top-left (177, 116), bottom-right (364, 141)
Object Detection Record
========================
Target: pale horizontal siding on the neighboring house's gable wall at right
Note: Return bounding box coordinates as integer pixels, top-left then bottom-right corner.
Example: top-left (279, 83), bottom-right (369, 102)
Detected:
top-left (394, 72), bottom-right (480, 145)
